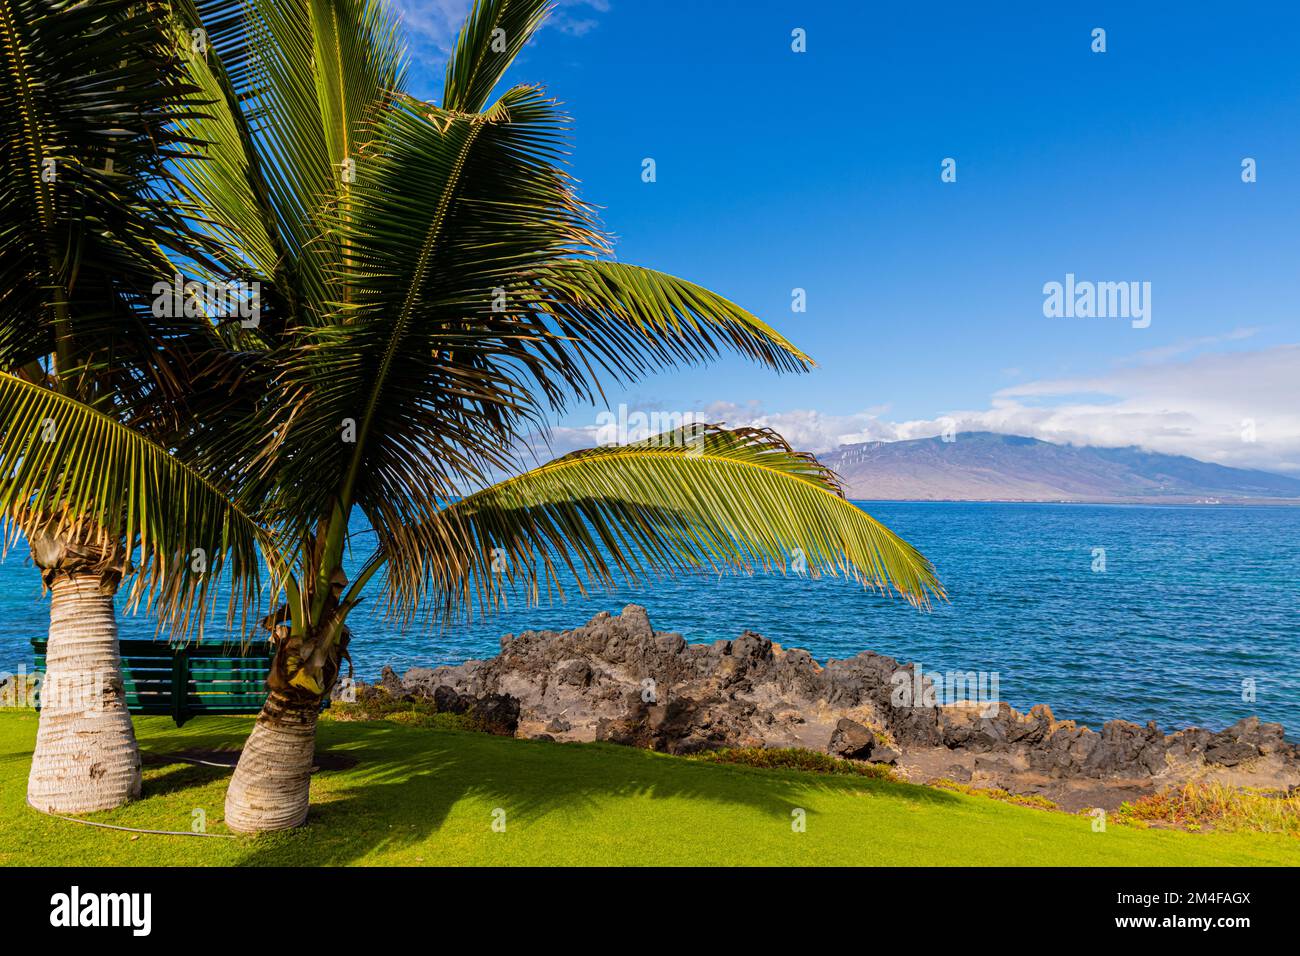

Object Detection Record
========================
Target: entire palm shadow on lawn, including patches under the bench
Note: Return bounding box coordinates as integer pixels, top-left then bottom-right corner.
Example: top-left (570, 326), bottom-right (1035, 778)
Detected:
top-left (0, 718), bottom-right (959, 866)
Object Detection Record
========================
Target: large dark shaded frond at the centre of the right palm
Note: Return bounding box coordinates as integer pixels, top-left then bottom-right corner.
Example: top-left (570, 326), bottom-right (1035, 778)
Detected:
top-left (267, 87), bottom-right (613, 530)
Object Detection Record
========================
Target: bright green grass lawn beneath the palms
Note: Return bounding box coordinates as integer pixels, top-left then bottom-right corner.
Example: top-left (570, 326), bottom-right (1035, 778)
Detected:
top-left (0, 710), bottom-right (1300, 866)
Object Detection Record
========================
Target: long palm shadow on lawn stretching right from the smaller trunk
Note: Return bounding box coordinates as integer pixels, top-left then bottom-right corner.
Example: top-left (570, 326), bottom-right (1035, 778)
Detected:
top-left (226, 722), bottom-right (957, 866)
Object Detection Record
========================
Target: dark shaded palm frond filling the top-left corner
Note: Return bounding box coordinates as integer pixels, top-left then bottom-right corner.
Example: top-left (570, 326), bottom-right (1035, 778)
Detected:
top-left (0, 0), bottom-right (215, 389)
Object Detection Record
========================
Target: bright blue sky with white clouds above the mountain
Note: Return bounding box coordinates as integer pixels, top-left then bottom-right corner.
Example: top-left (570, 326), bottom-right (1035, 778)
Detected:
top-left (387, 0), bottom-right (1300, 473)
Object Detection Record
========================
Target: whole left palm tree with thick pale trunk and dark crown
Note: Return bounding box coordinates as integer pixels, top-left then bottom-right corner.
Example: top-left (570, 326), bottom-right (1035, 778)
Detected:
top-left (0, 0), bottom-right (263, 813)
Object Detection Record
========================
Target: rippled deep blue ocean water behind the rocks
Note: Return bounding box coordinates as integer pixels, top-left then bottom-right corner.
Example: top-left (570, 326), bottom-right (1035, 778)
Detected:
top-left (0, 502), bottom-right (1300, 739)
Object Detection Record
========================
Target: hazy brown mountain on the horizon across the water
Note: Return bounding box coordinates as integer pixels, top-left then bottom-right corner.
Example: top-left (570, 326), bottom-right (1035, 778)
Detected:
top-left (820, 432), bottom-right (1300, 503)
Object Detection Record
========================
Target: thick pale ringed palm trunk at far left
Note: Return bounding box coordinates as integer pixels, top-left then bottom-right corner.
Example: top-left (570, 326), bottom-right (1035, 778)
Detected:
top-left (27, 572), bottom-right (140, 813)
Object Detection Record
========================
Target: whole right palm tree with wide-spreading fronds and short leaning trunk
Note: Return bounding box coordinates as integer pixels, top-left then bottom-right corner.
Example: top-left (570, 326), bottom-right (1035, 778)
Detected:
top-left (157, 0), bottom-right (940, 831)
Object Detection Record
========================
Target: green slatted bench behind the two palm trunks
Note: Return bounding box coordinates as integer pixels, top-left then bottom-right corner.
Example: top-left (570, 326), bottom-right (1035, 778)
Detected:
top-left (31, 639), bottom-right (279, 727)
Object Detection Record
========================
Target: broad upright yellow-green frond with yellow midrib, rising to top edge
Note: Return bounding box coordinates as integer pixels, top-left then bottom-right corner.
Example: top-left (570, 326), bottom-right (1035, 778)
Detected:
top-left (179, 0), bottom-right (404, 325)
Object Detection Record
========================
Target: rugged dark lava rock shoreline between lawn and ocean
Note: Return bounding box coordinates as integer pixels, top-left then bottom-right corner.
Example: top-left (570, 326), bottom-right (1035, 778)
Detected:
top-left (361, 605), bottom-right (1300, 810)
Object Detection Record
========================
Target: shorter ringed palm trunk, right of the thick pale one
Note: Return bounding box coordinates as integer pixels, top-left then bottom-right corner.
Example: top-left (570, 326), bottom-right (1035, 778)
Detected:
top-left (226, 689), bottom-right (320, 834)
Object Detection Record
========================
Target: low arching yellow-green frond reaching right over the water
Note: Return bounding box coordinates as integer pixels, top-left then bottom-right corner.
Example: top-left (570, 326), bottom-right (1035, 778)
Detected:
top-left (372, 425), bottom-right (944, 629)
